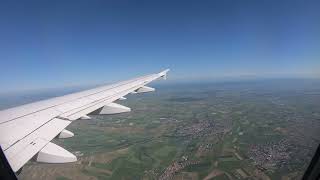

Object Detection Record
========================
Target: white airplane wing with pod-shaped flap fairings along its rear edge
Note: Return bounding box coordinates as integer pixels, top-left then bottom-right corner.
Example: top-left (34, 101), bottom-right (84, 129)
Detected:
top-left (0, 70), bottom-right (169, 172)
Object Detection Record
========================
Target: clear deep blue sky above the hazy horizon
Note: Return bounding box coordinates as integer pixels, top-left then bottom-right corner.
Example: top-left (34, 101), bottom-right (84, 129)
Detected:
top-left (0, 0), bottom-right (320, 91)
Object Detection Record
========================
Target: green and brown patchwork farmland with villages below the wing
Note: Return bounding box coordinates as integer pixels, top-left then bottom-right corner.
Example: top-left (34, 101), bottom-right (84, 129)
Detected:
top-left (0, 79), bottom-right (320, 180)
